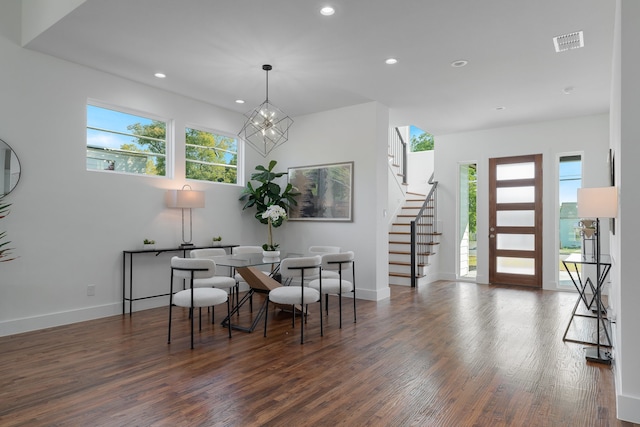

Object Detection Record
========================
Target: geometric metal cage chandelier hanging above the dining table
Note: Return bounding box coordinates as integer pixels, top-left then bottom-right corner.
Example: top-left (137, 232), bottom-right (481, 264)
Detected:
top-left (238, 64), bottom-right (293, 157)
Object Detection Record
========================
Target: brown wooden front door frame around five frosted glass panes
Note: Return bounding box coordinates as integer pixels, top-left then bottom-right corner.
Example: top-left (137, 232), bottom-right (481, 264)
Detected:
top-left (489, 154), bottom-right (543, 289)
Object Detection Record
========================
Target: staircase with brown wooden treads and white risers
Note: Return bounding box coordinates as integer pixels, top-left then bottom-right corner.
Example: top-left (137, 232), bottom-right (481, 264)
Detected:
top-left (389, 192), bottom-right (439, 286)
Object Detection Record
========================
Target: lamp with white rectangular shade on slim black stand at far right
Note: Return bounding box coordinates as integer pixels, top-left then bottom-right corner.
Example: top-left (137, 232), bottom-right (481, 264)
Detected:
top-left (578, 187), bottom-right (618, 364)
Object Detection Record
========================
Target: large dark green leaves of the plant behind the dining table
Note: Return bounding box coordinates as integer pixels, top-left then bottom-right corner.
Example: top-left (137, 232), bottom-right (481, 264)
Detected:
top-left (240, 160), bottom-right (300, 227)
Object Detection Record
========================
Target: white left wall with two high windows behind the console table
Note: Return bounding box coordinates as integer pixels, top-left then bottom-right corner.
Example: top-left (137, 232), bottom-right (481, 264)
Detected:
top-left (0, 25), bottom-right (260, 335)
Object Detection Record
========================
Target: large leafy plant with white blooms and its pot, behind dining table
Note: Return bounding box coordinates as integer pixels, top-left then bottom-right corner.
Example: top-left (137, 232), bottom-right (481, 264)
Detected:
top-left (240, 160), bottom-right (300, 256)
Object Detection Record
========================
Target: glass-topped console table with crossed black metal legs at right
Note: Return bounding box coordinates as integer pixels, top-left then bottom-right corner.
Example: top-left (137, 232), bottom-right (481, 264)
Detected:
top-left (562, 254), bottom-right (611, 347)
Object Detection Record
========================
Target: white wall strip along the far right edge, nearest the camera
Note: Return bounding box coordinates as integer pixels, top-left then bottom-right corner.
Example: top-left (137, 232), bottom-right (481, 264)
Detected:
top-left (611, 0), bottom-right (640, 423)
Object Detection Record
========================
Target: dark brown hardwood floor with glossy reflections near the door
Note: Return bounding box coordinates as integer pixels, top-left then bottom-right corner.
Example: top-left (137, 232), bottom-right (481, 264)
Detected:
top-left (0, 282), bottom-right (633, 426)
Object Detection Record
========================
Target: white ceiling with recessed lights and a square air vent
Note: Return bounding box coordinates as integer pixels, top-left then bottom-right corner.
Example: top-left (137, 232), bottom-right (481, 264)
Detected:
top-left (25, 0), bottom-right (615, 135)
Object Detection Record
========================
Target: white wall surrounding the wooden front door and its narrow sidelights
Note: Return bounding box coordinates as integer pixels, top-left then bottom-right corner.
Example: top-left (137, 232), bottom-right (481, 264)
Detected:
top-left (435, 115), bottom-right (609, 289)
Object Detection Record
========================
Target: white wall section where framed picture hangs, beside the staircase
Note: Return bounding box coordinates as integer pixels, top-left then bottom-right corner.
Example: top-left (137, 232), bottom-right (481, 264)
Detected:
top-left (274, 102), bottom-right (389, 300)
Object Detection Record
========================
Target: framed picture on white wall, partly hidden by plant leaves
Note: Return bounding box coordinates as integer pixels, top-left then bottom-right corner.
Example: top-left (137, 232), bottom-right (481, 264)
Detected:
top-left (288, 162), bottom-right (353, 222)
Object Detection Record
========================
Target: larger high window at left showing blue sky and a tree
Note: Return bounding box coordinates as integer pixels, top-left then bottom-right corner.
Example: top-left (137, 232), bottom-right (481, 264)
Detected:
top-left (86, 101), bottom-right (170, 177)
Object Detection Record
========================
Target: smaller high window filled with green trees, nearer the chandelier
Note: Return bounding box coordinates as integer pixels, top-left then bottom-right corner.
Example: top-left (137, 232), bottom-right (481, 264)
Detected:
top-left (185, 127), bottom-right (241, 184)
